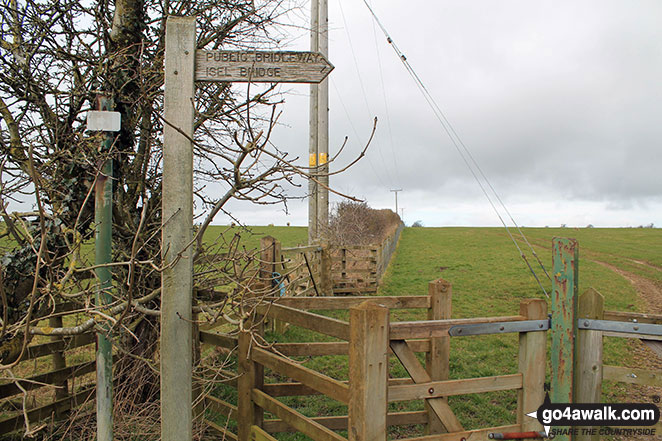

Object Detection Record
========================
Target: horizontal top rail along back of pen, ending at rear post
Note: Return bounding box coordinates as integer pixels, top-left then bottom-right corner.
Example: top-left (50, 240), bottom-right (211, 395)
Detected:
top-left (265, 296), bottom-right (430, 310)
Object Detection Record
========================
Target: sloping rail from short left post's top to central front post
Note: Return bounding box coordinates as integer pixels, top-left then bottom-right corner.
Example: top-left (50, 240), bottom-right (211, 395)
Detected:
top-left (251, 347), bottom-right (349, 404)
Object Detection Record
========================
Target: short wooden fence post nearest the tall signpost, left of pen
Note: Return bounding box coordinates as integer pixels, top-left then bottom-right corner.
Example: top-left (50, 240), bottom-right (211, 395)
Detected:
top-left (237, 324), bottom-right (264, 441)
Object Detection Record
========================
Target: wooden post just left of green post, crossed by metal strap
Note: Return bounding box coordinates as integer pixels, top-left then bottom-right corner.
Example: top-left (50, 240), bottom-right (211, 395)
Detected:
top-left (517, 299), bottom-right (547, 432)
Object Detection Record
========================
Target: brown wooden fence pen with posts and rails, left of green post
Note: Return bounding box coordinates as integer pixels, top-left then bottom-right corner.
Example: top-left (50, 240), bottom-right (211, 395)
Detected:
top-left (201, 280), bottom-right (547, 441)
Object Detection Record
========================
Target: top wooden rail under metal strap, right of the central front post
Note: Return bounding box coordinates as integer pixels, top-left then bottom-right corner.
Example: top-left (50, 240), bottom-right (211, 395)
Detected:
top-left (390, 315), bottom-right (526, 340)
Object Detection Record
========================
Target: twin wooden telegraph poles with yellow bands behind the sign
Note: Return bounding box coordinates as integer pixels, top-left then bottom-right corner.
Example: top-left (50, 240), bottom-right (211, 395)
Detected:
top-left (308, 0), bottom-right (329, 244)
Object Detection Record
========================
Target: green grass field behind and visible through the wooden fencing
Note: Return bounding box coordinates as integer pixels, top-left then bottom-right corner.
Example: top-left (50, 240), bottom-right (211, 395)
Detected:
top-left (209, 227), bottom-right (662, 440)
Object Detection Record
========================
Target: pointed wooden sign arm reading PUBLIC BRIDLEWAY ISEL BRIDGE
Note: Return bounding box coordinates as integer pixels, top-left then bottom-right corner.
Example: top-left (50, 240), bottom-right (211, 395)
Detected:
top-left (195, 50), bottom-right (333, 83)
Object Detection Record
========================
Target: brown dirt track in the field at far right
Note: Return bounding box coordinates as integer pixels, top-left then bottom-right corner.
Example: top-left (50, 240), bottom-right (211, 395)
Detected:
top-left (595, 260), bottom-right (662, 441)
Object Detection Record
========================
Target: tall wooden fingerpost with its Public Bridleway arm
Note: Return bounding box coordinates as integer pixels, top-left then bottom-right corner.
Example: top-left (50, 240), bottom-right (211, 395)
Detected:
top-left (161, 17), bottom-right (333, 441)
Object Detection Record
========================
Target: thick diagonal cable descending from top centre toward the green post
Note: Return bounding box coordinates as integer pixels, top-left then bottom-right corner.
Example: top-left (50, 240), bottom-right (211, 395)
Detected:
top-left (363, 0), bottom-right (549, 297)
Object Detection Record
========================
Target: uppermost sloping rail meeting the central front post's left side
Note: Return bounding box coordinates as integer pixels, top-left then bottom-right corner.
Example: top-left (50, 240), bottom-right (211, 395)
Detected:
top-left (257, 297), bottom-right (349, 340)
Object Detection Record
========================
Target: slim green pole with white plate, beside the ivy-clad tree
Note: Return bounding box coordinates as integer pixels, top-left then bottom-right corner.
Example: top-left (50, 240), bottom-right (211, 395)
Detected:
top-left (94, 96), bottom-right (113, 441)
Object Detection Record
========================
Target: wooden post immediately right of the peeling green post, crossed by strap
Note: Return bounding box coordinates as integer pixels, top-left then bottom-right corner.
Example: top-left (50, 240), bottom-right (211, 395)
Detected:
top-left (574, 288), bottom-right (604, 441)
